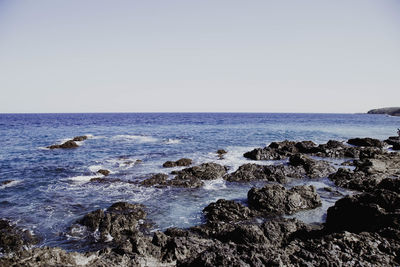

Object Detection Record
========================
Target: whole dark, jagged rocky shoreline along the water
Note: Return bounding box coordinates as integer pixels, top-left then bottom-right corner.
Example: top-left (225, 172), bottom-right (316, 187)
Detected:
top-left (0, 137), bottom-right (400, 266)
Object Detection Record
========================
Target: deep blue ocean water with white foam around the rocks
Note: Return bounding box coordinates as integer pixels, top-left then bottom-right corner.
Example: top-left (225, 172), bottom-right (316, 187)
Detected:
top-left (0, 113), bottom-right (400, 250)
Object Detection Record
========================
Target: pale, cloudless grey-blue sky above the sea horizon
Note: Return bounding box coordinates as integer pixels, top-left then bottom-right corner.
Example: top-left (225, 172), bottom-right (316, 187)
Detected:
top-left (0, 0), bottom-right (400, 113)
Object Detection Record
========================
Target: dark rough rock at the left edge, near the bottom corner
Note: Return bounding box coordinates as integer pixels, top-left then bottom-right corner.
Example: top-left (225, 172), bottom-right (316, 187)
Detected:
top-left (0, 219), bottom-right (38, 253)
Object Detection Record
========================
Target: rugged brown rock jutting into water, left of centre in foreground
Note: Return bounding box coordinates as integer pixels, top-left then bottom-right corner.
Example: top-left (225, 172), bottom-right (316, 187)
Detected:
top-left (77, 202), bottom-right (146, 242)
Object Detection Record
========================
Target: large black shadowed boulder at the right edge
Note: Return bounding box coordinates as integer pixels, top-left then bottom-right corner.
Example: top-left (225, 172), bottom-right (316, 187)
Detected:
top-left (326, 189), bottom-right (400, 233)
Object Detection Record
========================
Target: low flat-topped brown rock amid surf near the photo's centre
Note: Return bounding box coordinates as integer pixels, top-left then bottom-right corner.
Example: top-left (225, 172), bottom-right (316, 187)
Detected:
top-left (172, 162), bottom-right (227, 180)
